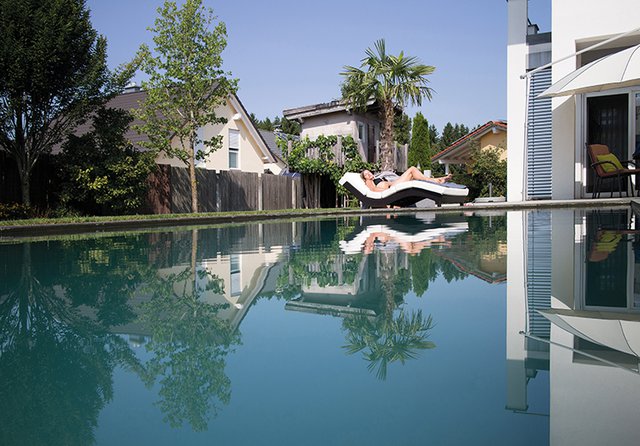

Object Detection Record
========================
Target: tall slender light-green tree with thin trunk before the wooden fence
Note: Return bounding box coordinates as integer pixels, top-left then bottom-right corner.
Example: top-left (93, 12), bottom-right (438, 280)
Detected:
top-left (135, 0), bottom-right (237, 212)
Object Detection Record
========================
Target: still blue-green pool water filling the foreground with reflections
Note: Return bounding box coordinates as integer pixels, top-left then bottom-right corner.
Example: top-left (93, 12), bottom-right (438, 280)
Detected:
top-left (0, 209), bottom-right (640, 445)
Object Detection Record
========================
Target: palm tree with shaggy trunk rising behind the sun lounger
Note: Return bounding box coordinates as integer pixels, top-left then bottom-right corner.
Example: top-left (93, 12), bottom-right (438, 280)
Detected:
top-left (340, 39), bottom-right (435, 170)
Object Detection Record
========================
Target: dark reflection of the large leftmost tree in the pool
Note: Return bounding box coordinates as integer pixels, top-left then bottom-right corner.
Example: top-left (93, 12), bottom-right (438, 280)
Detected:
top-left (0, 243), bottom-right (140, 445)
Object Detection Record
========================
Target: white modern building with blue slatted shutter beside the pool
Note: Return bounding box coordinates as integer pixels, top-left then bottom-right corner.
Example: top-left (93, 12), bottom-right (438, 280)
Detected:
top-left (507, 0), bottom-right (640, 201)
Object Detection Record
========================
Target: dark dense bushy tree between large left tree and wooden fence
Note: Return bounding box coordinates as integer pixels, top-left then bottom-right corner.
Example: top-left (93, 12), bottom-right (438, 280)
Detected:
top-left (59, 108), bottom-right (156, 214)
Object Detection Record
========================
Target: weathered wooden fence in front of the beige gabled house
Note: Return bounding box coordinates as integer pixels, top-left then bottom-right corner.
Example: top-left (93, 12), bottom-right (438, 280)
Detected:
top-left (146, 165), bottom-right (302, 214)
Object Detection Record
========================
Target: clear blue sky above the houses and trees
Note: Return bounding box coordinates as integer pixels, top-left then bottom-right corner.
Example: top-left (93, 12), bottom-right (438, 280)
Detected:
top-left (87, 0), bottom-right (550, 130)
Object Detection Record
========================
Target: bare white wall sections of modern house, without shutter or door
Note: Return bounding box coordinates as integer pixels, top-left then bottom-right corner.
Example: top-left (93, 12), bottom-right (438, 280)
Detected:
top-left (507, 0), bottom-right (640, 201)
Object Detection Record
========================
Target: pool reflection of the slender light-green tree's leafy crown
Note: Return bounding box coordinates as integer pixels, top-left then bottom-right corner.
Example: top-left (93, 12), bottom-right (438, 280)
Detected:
top-left (140, 267), bottom-right (240, 430)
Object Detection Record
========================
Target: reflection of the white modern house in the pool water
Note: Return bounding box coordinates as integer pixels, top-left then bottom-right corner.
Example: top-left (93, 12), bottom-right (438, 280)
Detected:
top-left (506, 209), bottom-right (640, 444)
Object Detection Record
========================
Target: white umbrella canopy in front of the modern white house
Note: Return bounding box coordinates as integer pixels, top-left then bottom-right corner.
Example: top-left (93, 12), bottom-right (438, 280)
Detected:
top-left (538, 45), bottom-right (640, 98)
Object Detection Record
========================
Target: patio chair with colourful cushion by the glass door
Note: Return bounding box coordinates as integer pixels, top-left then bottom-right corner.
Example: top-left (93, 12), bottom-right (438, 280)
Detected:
top-left (587, 144), bottom-right (640, 198)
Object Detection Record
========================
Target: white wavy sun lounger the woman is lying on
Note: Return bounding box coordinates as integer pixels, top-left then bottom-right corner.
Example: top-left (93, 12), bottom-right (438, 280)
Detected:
top-left (340, 172), bottom-right (469, 208)
